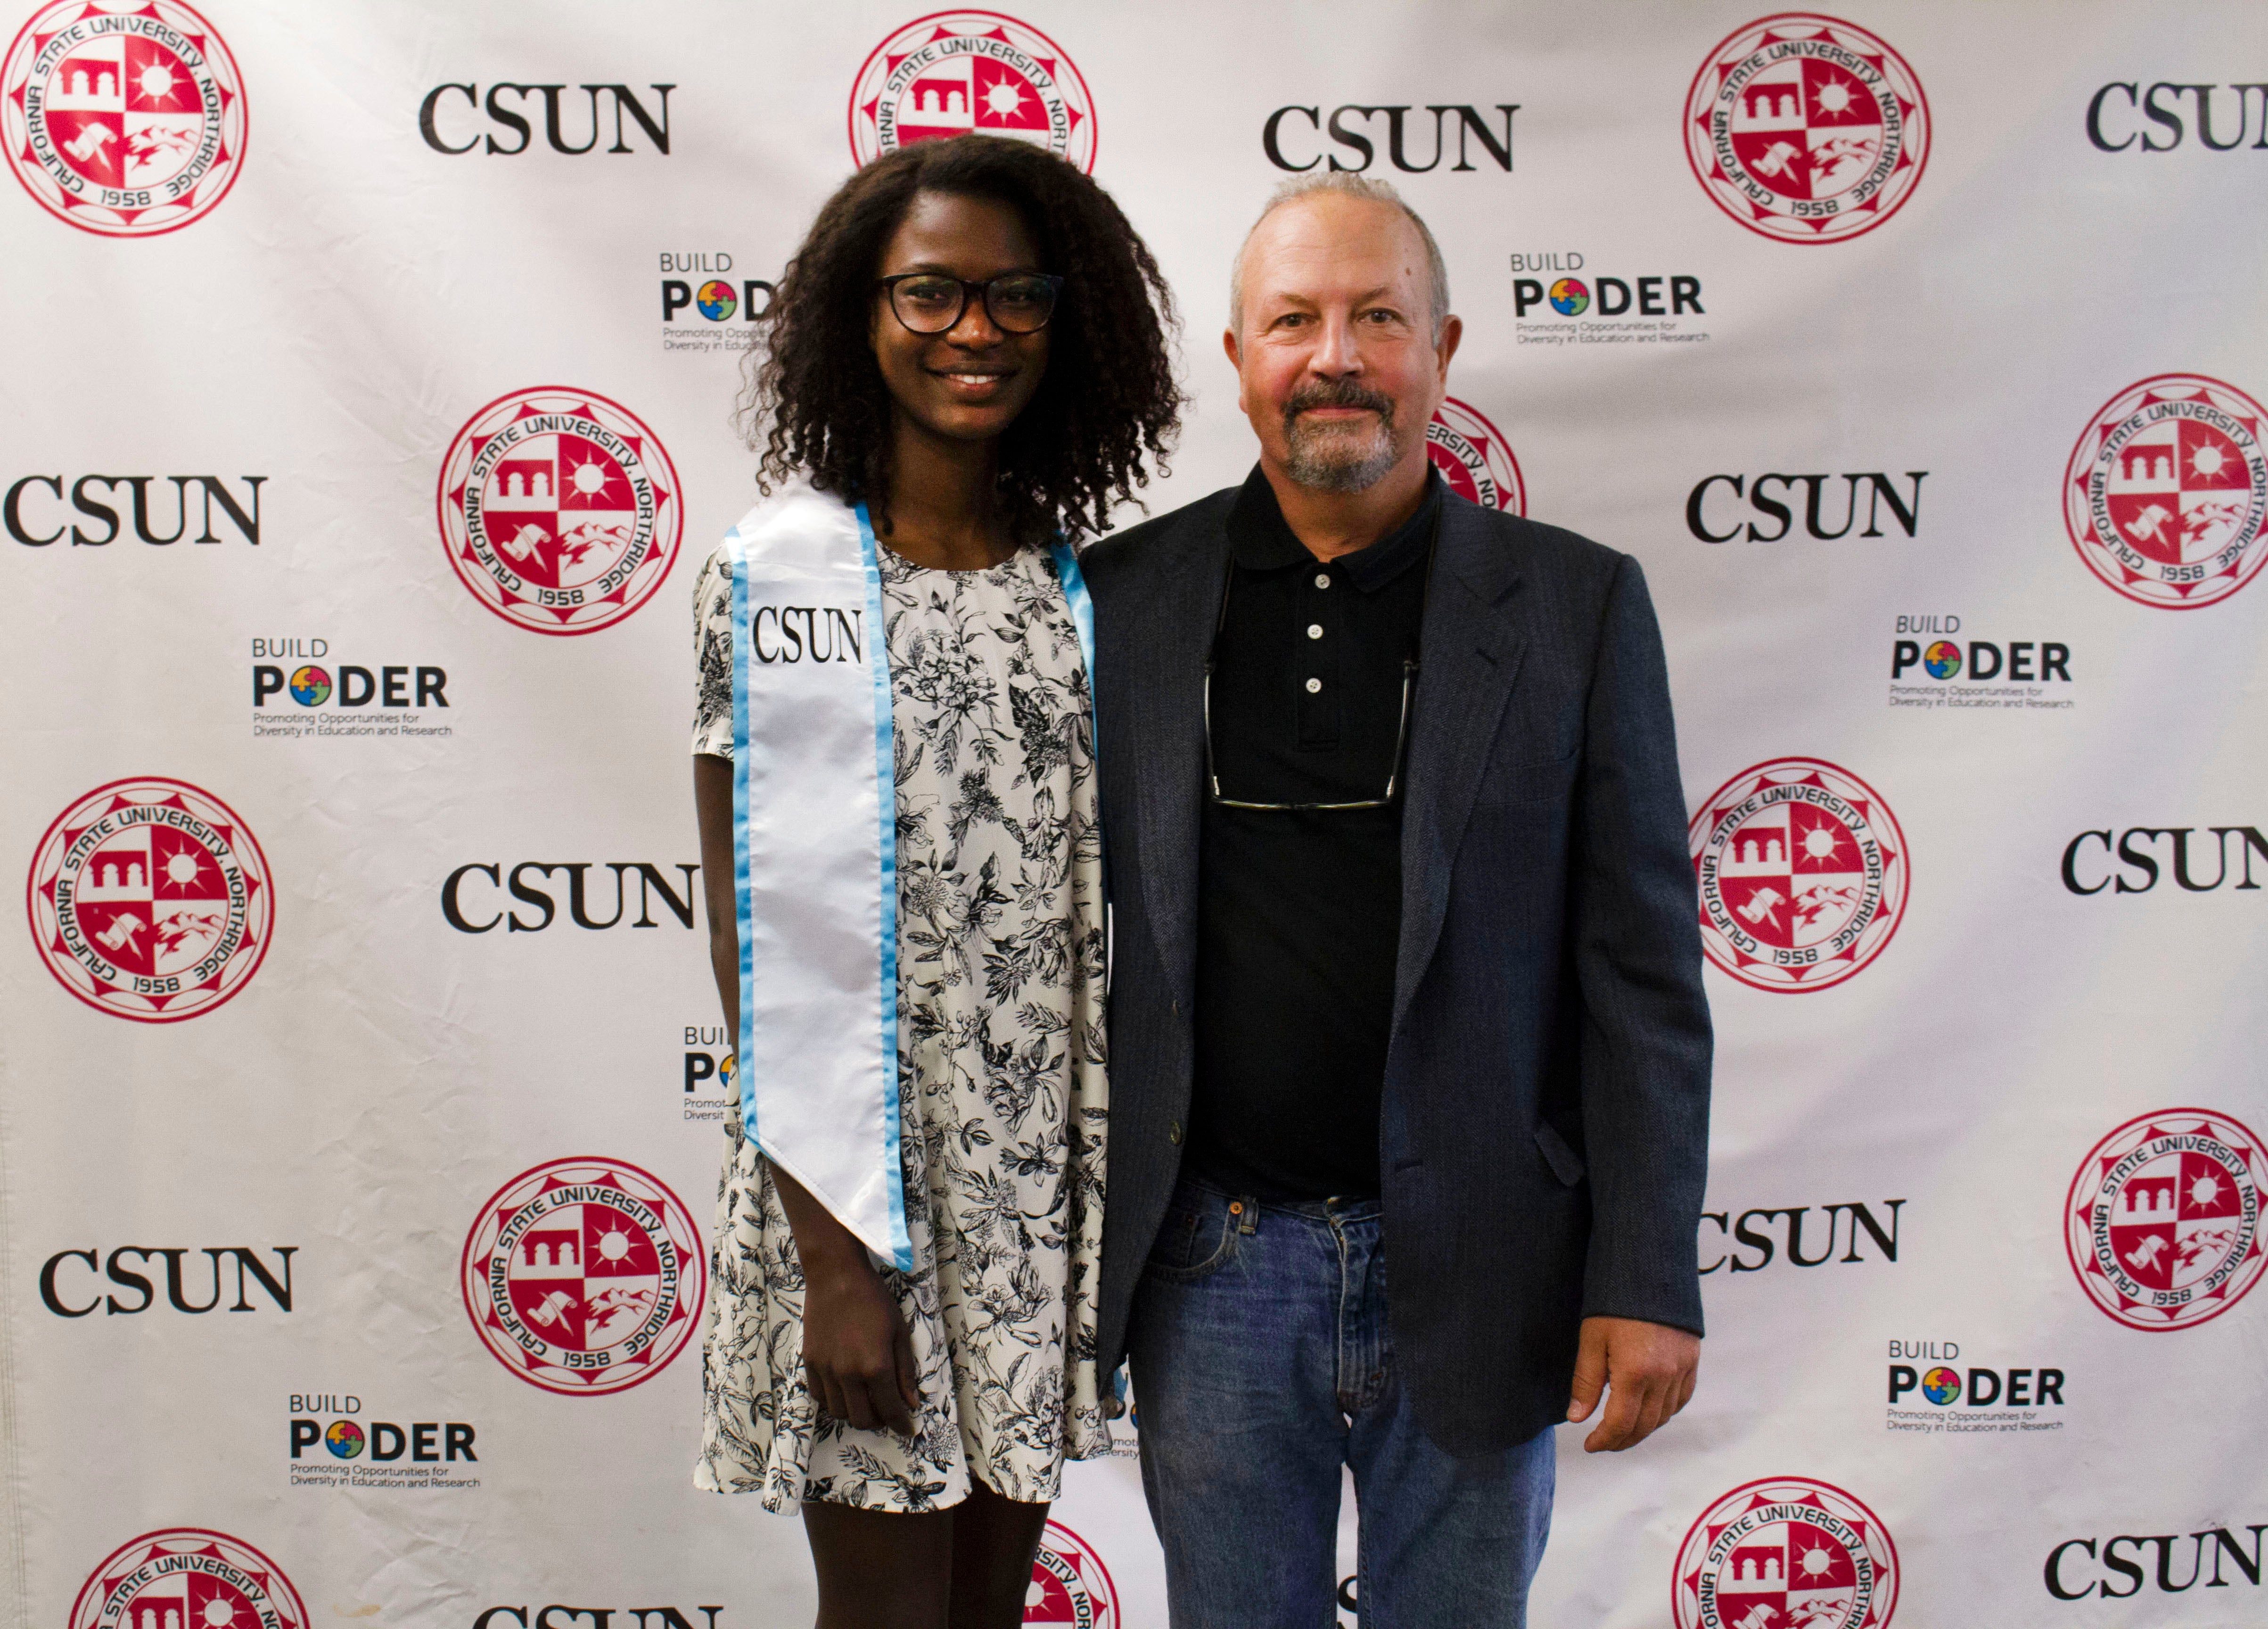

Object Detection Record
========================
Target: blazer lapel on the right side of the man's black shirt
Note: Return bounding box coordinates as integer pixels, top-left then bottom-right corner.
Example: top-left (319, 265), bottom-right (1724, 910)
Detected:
top-left (1395, 497), bottom-right (1524, 1030)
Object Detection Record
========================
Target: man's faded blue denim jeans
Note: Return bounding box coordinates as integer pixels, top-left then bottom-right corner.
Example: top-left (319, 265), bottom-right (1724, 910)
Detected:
top-left (1127, 1177), bottom-right (1553, 1629)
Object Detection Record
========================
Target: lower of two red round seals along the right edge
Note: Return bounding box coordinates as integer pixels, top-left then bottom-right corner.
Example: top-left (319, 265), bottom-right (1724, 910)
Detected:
top-left (2064, 1110), bottom-right (2268, 1330)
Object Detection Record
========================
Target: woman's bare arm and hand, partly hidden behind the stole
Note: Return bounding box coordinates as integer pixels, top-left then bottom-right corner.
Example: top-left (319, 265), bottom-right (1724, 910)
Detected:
top-left (694, 753), bottom-right (921, 1434)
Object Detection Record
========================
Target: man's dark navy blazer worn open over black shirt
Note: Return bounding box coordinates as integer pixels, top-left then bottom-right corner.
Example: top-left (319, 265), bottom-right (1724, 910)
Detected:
top-left (1082, 488), bottom-right (1710, 1454)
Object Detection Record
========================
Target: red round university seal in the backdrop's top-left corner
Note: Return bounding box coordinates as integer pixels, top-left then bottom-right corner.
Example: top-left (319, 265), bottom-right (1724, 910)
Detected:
top-left (0, 0), bottom-right (245, 238)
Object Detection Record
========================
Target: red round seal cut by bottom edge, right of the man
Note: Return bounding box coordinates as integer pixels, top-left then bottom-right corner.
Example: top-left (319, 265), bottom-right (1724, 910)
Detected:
top-left (1669, 1477), bottom-right (1898, 1629)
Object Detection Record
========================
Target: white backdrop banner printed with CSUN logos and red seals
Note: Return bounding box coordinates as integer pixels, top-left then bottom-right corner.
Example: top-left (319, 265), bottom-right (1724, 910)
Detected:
top-left (0, 0), bottom-right (2268, 1629)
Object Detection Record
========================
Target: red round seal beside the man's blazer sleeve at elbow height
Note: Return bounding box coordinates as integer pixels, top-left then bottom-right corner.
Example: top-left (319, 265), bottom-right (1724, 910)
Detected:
top-left (1687, 758), bottom-right (1910, 991)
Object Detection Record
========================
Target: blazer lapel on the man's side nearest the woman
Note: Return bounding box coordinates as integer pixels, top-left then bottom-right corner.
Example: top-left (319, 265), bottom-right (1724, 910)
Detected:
top-left (1127, 519), bottom-right (1229, 1012)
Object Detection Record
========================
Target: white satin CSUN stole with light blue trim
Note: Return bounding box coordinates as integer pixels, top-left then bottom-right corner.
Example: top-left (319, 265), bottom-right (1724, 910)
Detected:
top-left (726, 483), bottom-right (1095, 1270)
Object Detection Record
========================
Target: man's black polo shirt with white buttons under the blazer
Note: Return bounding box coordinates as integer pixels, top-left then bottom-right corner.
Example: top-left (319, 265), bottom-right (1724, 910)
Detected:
top-left (1186, 458), bottom-right (1442, 1200)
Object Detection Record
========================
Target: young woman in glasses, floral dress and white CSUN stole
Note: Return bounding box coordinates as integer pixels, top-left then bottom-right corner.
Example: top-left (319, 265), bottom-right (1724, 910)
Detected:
top-left (694, 136), bottom-right (1179, 1629)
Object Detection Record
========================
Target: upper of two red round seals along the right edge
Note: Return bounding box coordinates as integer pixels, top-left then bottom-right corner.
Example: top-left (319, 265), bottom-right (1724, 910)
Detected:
top-left (2064, 374), bottom-right (2268, 610)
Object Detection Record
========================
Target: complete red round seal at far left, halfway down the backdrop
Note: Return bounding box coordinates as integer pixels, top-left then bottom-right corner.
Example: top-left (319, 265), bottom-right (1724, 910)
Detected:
top-left (25, 776), bottom-right (274, 1023)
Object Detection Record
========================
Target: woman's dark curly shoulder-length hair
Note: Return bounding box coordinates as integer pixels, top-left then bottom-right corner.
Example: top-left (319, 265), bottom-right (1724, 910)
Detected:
top-left (740, 136), bottom-right (1182, 542)
